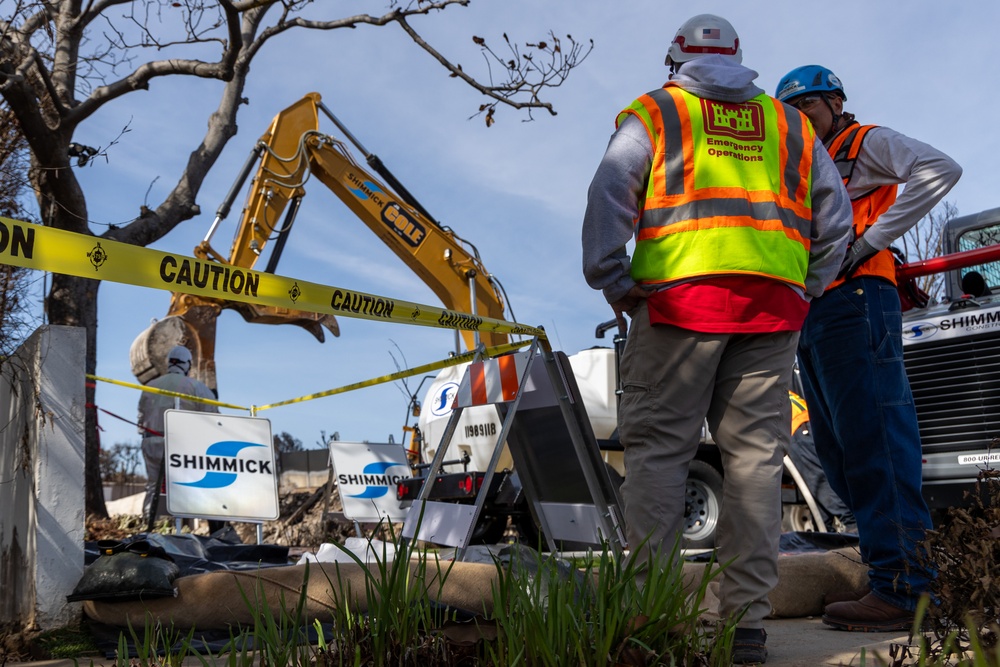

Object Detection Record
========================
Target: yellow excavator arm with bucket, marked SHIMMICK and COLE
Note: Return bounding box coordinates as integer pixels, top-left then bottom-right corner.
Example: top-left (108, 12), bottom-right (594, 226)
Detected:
top-left (129, 93), bottom-right (507, 392)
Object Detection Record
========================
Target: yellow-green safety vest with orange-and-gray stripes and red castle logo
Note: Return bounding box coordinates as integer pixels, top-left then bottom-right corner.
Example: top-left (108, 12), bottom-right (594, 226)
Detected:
top-left (618, 83), bottom-right (814, 287)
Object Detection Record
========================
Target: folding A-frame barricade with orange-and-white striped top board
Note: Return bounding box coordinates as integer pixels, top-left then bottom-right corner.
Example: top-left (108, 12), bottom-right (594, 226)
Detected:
top-left (403, 338), bottom-right (625, 560)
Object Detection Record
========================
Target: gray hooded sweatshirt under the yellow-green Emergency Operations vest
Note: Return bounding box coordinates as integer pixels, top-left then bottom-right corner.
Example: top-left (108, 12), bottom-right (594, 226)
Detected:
top-left (583, 55), bottom-right (853, 303)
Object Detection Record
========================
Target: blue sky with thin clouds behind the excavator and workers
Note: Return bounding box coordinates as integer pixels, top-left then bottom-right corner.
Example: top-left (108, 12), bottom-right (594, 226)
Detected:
top-left (39, 0), bottom-right (1000, 454)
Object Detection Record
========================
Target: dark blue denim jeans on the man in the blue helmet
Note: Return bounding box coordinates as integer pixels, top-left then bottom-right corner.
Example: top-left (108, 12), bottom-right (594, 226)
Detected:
top-left (799, 277), bottom-right (932, 610)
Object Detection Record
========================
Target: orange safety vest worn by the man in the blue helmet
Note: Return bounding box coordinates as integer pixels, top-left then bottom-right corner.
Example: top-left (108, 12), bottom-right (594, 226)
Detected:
top-left (827, 122), bottom-right (898, 290)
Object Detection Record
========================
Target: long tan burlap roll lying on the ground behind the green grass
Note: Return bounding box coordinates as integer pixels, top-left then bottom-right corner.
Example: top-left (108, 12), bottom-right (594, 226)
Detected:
top-left (83, 548), bottom-right (868, 631)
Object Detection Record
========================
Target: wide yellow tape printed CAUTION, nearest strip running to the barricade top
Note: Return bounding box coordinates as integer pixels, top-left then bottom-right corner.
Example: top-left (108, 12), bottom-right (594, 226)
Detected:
top-left (0, 217), bottom-right (545, 338)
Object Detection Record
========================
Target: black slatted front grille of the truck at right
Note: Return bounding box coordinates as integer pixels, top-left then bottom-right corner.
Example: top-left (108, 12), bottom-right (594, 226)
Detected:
top-left (903, 333), bottom-right (1000, 453)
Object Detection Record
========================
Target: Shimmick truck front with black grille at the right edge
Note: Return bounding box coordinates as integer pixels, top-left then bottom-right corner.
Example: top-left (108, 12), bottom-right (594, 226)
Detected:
top-left (902, 208), bottom-right (1000, 512)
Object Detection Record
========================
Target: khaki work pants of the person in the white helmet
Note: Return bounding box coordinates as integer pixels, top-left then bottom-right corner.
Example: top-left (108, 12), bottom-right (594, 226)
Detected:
top-left (619, 304), bottom-right (798, 628)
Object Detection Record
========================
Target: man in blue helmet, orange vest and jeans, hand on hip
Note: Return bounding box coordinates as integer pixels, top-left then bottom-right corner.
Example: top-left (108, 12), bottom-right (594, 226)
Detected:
top-left (776, 65), bottom-right (962, 632)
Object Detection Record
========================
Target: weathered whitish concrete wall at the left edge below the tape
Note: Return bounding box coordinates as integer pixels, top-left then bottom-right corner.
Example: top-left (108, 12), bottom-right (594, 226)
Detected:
top-left (0, 326), bottom-right (86, 630)
